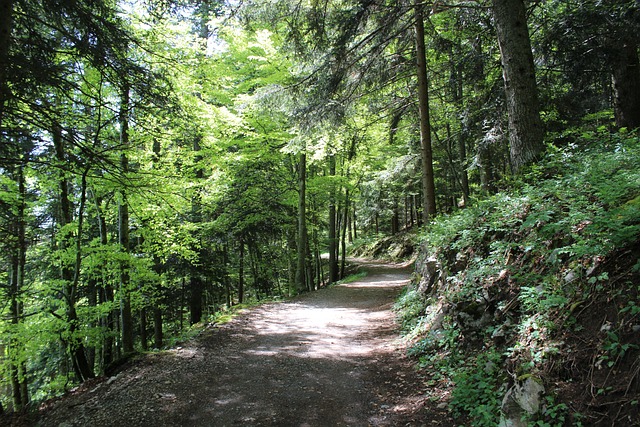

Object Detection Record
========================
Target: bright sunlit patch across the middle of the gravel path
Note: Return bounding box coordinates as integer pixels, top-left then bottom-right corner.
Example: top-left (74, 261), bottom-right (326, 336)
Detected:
top-left (239, 272), bottom-right (407, 361)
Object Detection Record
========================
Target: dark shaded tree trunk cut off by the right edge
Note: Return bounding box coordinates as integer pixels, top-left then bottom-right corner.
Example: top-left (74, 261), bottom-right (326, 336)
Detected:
top-left (611, 40), bottom-right (640, 129)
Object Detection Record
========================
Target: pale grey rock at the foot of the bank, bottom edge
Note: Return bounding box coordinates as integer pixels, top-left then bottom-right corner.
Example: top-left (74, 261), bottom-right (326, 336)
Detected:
top-left (499, 377), bottom-right (544, 427)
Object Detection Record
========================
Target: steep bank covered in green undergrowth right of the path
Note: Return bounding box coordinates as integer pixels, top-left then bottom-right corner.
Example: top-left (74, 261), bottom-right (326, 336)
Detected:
top-left (396, 130), bottom-right (640, 426)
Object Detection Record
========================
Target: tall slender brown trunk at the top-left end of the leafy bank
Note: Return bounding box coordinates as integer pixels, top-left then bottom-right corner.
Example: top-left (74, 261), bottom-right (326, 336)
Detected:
top-left (415, 3), bottom-right (436, 224)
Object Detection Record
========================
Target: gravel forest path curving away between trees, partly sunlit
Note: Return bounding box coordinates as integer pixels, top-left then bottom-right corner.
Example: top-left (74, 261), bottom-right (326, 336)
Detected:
top-left (37, 260), bottom-right (450, 427)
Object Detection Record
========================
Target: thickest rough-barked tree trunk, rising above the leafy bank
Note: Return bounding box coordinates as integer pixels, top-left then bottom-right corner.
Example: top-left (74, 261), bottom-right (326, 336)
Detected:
top-left (493, 0), bottom-right (544, 173)
